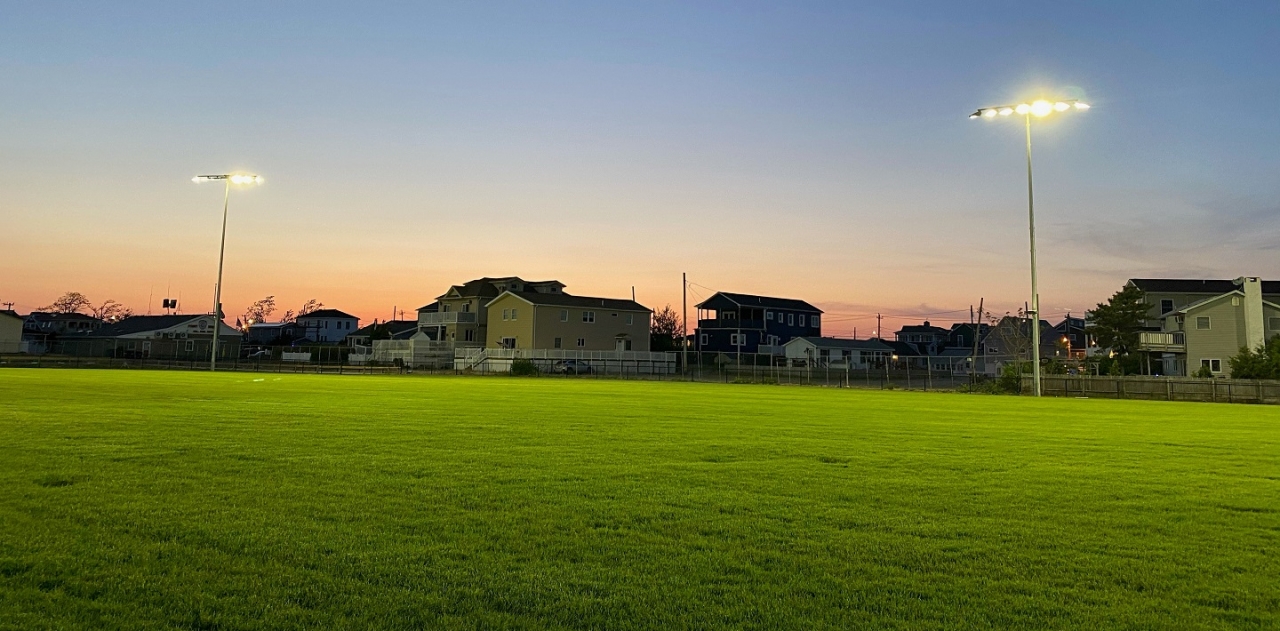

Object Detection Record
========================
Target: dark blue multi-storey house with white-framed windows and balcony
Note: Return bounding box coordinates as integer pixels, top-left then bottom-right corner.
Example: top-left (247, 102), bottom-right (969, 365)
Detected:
top-left (694, 292), bottom-right (822, 355)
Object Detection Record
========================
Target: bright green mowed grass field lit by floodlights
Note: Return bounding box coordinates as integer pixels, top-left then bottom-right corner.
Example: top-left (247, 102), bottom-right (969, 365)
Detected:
top-left (0, 370), bottom-right (1280, 630)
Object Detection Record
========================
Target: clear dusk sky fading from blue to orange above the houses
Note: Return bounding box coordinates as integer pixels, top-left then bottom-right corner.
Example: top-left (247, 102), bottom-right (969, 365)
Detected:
top-left (0, 1), bottom-right (1280, 338)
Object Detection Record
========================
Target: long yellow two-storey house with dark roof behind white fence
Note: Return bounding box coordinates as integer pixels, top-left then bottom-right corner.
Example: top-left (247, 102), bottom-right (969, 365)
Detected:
top-left (485, 291), bottom-right (653, 352)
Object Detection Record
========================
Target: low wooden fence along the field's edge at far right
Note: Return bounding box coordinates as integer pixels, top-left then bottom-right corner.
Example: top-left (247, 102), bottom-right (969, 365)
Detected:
top-left (1023, 375), bottom-right (1280, 404)
